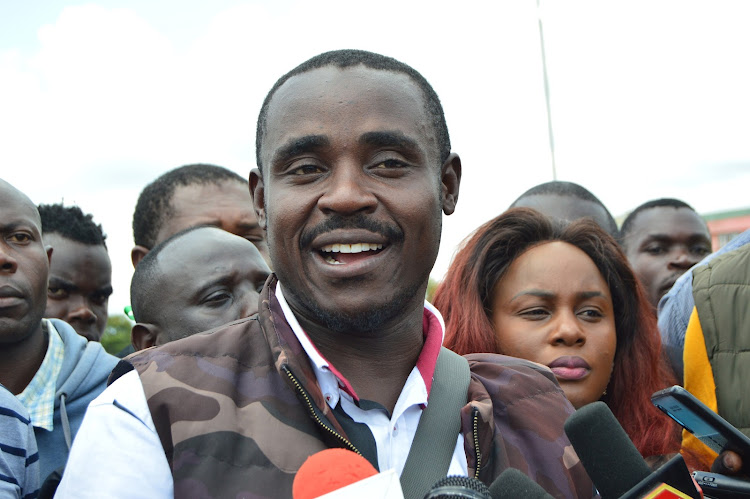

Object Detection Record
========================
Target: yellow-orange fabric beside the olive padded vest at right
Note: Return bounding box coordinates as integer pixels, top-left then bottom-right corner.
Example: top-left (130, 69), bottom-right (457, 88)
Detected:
top-left (682, 307), bottom-right (718, 469)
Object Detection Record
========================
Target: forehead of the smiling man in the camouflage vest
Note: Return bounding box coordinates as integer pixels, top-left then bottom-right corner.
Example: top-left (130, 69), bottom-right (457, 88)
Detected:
top-left (262, 65), bottom-right (438, 165)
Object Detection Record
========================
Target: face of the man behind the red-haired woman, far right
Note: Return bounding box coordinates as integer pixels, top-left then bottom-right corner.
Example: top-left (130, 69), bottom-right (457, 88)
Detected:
top-left (624, 206), bottom-right (711, 307)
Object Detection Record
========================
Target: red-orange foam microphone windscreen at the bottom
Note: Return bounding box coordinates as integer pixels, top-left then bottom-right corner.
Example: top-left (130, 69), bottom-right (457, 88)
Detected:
top-left (292, 449), bottom-right (378, 499)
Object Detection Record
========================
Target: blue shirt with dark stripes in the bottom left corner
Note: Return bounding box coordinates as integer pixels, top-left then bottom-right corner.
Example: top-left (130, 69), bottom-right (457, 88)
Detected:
top-left (0, 385), bottom-right (39, 498)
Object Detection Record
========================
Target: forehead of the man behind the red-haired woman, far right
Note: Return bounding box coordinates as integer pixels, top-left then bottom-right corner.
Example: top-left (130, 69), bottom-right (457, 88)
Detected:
top-left (629, 206), bottom-right (709, 239)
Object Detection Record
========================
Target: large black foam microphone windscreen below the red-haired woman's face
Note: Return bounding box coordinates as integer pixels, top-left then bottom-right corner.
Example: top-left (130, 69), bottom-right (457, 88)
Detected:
top-left (565, 402), bottom-right (651, 499)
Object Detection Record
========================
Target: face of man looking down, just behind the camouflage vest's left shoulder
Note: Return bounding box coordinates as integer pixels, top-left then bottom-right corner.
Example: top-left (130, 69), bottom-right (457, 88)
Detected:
top-left (149, 227), bottom-right (270, 344)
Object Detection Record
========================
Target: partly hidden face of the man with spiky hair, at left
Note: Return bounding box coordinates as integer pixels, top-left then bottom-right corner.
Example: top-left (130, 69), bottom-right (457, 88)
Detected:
top-left (44, 232), bottom-right (112, 341)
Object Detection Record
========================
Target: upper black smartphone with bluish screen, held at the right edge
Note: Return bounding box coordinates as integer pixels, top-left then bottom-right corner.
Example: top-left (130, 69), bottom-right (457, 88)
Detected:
top-left (651, 385), bottom-right (750, 460)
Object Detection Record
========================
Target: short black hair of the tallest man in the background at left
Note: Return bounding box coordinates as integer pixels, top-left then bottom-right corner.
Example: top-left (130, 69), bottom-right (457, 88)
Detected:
top-left (133, 163), bottom-right (247, 249)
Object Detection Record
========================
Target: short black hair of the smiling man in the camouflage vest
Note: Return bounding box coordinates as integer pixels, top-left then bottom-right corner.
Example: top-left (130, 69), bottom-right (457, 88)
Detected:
top-left (255, 49), bottom-right (451, 171)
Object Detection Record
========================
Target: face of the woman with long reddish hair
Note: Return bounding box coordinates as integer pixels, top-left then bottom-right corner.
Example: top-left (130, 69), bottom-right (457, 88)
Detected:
top-left (490, 241), bottom-right (617, 409)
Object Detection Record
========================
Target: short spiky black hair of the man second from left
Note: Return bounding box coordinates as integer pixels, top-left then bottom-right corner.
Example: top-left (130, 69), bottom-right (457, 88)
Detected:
top-left (37, 203), bottom-right (107, 248)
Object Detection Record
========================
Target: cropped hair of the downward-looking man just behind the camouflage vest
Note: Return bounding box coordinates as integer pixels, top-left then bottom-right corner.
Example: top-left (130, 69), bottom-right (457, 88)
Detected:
top-left (130, 224), bottom-right (210, 322)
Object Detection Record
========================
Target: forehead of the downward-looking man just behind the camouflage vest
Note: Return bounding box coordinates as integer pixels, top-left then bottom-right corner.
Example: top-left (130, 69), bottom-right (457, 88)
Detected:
top-left (157, 227), bottom-right (267, 285)
